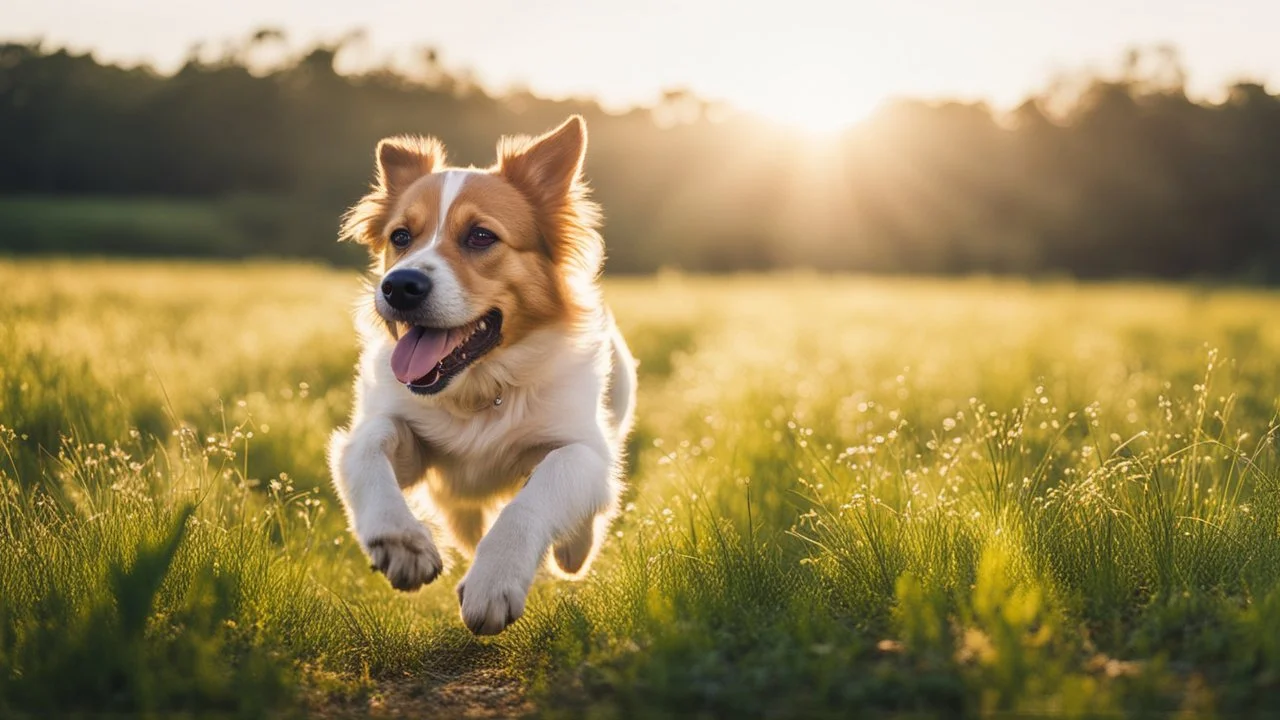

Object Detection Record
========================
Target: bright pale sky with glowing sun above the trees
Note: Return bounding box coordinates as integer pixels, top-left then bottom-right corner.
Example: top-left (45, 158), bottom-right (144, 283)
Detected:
top-left (10, 0), bottom-right (1280, 128)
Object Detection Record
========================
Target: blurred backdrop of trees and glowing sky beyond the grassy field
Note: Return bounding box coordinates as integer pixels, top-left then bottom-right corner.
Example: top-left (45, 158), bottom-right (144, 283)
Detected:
top-left (0, 0), bottom-right (1280, 283)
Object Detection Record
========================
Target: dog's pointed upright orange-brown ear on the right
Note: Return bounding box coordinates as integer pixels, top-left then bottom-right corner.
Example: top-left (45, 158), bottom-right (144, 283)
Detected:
top-left (498, 115), bottom-right (586, 210)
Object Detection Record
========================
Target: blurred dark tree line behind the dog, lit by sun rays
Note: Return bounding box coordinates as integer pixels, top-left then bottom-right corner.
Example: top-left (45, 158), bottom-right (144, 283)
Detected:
top-left (0, 32), bottom-right (1280, 282)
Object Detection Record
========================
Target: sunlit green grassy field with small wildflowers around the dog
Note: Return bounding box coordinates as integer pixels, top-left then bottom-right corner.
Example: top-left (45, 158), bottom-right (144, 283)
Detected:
top-left (0, 256), bottom-right (1280, 717)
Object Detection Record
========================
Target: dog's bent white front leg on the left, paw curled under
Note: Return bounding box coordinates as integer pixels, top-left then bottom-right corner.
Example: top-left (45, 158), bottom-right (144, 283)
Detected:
top-left (329, 416), bottom-right (444, 591)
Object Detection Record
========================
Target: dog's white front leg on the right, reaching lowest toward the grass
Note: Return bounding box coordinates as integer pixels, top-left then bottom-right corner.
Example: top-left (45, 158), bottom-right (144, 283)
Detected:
top-left (458, 443), bottom-right (614, 635)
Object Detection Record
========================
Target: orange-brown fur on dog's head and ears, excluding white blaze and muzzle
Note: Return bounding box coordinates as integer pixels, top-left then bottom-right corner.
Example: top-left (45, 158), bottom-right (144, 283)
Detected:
top-left (342, 115), bottom-right (604, 343)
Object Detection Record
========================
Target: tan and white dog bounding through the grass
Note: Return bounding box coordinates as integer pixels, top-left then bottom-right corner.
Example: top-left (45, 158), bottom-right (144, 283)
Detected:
top-left (329, 115), bottom-right (636, 634)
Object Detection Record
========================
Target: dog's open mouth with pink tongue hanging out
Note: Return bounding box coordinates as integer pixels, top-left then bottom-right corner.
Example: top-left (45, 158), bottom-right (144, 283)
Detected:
top-left (392, 307), bottom-right (502, 395)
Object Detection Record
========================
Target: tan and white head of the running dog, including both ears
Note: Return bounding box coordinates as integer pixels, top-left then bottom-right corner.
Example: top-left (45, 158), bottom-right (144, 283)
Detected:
top-left (343, 115), bottom-right (603, 395)
